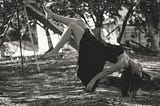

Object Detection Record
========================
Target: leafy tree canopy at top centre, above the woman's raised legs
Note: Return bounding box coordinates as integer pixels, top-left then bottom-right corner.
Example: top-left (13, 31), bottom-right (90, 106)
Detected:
top-left (43, 0), bottom-right (133, 40)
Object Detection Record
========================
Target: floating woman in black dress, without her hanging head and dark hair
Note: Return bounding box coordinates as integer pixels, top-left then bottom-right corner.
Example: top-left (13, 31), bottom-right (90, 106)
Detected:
top-left (43, 6), bottom-right (141, 91)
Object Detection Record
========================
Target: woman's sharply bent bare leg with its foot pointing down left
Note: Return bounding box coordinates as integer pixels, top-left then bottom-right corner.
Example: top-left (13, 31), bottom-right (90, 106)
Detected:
top-left (43, 22), bottom-right (84, 58)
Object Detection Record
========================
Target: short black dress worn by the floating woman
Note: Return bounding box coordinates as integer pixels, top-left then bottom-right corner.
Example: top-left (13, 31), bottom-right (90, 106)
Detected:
top-left (77, 29), bottom-right (124, 90)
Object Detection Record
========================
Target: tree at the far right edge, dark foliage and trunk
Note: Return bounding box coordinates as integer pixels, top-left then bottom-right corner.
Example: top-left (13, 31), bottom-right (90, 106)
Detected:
top-left (139, 0), bottom-right (160, 52)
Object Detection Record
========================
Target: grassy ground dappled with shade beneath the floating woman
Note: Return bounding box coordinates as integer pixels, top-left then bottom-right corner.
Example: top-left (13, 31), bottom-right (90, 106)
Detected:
top-left (0, 52), bottom-right (160, 106)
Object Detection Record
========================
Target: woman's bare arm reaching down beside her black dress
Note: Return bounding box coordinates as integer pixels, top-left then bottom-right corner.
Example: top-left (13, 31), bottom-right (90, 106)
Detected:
top-left (86, 53), bottom-right (129, 91)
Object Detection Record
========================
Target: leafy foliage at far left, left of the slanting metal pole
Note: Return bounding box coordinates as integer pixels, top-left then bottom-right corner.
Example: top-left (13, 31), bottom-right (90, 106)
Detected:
top-left (0, 0), bottom-right (36, 41)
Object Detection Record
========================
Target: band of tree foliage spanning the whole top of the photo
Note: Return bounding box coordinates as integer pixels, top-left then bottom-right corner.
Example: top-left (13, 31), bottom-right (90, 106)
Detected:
top-left (0, 0), bottom-right (160, 51)
